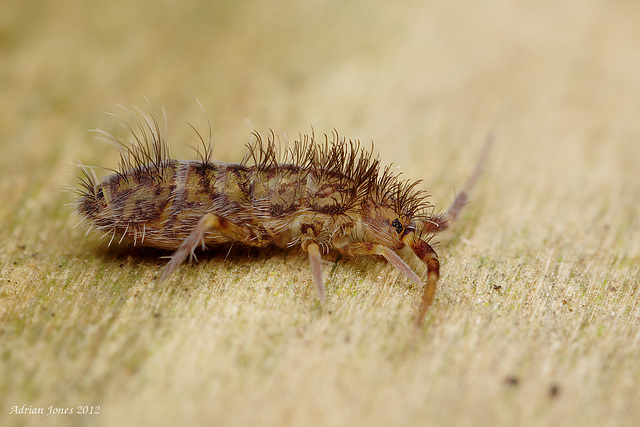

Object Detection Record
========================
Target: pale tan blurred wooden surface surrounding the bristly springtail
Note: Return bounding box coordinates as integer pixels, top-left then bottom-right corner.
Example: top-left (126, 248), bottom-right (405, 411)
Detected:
top-left (0, 0), bottom-right (640, 426)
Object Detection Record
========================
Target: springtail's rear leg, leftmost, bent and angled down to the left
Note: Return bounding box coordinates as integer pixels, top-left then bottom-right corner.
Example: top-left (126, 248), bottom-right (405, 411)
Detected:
top-left (160, 213), bottom-right (248, 282)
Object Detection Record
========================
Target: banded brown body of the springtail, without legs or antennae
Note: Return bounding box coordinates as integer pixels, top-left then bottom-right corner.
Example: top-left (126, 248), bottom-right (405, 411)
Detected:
top-left (84, 160), bottom-right (404, 252)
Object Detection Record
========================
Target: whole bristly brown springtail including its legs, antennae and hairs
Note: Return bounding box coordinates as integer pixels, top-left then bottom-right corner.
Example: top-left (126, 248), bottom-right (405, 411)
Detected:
top-left (76, 111), bottom-right (489, 325)
